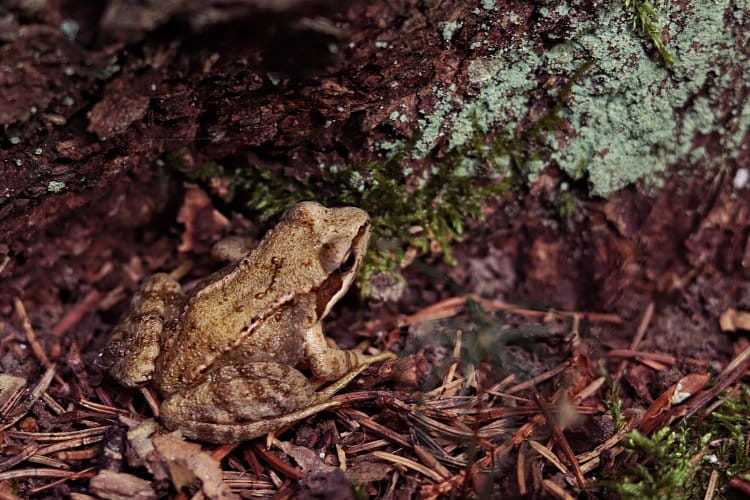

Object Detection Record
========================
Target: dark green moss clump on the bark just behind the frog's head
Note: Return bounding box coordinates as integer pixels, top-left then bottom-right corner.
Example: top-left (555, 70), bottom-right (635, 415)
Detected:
top-left (181, 135), bottom-right (515, 294)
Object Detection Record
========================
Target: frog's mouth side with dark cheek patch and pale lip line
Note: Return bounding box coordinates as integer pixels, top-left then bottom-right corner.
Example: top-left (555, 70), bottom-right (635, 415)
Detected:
top-left (315, 221), bottom-right (370, 318)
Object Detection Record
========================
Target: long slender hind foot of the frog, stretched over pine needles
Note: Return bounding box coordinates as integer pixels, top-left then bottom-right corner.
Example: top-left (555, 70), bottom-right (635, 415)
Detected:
top-left (167, 401), bottom-right (341, 444)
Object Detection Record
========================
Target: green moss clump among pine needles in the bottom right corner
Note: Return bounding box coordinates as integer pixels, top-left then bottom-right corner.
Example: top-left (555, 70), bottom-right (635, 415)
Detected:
top-left (601, 386), bottom-right (750, 500)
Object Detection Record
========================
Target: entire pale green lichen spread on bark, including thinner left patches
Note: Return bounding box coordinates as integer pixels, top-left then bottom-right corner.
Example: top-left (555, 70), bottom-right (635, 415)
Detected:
top-left (412, 0), bottom-right (750, 195)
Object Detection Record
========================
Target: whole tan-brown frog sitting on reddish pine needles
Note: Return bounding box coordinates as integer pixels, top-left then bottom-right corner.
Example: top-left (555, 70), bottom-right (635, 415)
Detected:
top-left (100, 201), bottom-right (395, 443)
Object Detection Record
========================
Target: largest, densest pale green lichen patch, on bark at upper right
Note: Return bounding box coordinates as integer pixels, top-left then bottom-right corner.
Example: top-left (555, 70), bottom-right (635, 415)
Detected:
top-left (546, 0), bottom-right (748, 194)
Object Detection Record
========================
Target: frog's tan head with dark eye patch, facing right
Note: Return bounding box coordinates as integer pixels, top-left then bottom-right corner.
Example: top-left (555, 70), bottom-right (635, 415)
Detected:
top-left (285, 201), bottom-right (370, 317)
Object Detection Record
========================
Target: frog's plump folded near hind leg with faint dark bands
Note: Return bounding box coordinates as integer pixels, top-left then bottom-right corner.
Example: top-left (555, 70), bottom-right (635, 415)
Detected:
top-left (161, 362), bottom-right (322, 442)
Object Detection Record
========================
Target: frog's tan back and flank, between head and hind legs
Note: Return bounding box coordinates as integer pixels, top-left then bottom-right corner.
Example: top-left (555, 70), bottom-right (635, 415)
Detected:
top-left (156, 223), bottom-right (318, 394)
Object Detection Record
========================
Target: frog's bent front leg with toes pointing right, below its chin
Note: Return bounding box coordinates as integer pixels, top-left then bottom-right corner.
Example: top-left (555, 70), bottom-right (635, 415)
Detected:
top-left (305, 323), bottom-right (395, 380)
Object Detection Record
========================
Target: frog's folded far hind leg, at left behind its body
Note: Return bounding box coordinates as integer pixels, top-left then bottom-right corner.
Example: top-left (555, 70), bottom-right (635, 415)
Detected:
top-left (100, 273), bottom-right (184, 387)
